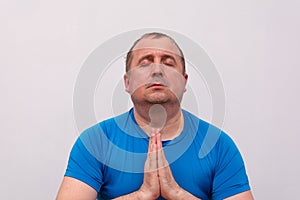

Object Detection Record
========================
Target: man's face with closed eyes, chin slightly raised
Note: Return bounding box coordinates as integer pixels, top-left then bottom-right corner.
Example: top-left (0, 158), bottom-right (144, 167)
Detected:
top-left (124, 37), bottom-right (188, 104)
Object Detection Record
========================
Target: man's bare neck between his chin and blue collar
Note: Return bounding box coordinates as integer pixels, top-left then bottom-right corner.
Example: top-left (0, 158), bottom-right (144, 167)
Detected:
top-left (134, 104), bottom-right (184, 141)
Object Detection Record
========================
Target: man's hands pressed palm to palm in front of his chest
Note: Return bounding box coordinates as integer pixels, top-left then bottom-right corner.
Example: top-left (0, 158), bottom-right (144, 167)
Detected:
top-left (138, 130), bottom-right (184, 200)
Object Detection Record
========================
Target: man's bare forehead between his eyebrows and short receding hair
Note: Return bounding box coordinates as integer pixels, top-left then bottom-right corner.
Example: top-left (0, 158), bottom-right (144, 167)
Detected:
top-left (132, 37), bottom-right (181, 56)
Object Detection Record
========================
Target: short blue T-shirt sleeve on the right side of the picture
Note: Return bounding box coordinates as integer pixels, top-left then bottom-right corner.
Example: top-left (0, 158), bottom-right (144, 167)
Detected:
top-left (212, 133), bottom-right (250, 200)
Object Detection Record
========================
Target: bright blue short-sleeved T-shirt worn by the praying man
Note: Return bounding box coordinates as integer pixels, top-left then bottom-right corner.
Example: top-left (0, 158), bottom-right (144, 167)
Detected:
top-left (65, 109), bottom-right (250, 200)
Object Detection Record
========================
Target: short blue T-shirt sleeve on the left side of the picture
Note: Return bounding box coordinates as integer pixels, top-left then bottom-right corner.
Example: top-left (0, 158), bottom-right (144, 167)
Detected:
top-left (65, 128), bottom-right (103, 192)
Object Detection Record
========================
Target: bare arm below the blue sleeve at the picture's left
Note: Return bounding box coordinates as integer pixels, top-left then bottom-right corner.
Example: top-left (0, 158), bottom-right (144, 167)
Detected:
top-left (56, 176), bottom-right (97, 200)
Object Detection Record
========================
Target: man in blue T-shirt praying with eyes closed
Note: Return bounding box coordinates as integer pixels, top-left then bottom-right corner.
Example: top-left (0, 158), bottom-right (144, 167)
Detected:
top-left (57, 33), bottom-right (253, 200)
